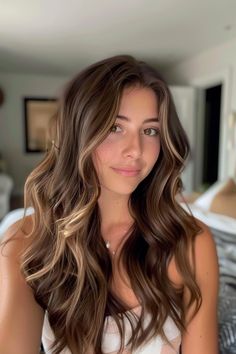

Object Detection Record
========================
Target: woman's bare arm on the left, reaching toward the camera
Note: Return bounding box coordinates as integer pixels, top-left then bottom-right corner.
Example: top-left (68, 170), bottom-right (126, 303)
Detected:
top-left (0, 216), bottom-right (44, 354)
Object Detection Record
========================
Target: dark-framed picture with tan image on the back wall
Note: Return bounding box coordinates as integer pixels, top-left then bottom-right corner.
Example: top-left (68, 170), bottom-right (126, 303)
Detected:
top-left (24, 97), bottom-right (57, 152)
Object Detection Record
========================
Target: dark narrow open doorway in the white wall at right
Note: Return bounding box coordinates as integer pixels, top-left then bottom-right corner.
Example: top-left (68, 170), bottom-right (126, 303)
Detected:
top-left (202, 85), bottom-right (222, 185)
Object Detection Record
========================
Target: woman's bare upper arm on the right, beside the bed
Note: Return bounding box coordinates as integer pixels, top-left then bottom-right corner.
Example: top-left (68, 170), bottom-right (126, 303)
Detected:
top-left (182, 223), bottom-right (219, 354)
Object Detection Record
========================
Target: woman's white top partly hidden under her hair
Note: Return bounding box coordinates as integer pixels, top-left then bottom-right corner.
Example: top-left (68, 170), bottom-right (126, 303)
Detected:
top-left (42, 306), bottom-right (181, 354)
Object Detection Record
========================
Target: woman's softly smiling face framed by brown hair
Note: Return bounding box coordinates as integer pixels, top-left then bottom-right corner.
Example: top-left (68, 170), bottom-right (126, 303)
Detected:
top-left (93, 87), bottom-right (160, 195)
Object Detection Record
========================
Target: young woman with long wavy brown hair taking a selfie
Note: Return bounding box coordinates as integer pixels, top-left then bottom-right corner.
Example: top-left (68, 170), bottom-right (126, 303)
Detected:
top-left (0, 55), bottom-right (218, 354)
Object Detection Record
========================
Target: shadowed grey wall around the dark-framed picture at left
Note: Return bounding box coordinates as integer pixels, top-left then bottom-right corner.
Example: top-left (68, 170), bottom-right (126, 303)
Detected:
top-left (0, 73), bottom-right (69, 195)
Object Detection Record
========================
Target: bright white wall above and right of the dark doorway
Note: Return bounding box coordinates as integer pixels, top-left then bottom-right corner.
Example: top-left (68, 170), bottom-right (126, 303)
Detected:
top-left (164, 38), bottom-right (236, 178)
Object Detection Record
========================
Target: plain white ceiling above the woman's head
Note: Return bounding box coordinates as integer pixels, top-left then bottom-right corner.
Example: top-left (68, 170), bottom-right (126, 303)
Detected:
top-left (0, 0), bottom-right (236, 75)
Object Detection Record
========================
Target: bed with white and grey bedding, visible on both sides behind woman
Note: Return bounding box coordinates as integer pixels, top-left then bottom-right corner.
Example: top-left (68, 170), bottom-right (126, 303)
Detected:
top-left (0, 203), bottom-right (236, 354)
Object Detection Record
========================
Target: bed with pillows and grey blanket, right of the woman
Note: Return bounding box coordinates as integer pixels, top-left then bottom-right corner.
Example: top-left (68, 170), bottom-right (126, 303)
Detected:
top-left (182, 179), bottom-right (236, 354)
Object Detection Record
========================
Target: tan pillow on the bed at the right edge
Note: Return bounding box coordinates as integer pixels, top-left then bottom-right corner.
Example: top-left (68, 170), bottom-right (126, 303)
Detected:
top-left (210, 178), bottom-right (236, 219)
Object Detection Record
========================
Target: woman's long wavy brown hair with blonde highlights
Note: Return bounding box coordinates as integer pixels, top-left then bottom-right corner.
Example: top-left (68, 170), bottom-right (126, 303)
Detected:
top-left (17, 55), bottom-right (201, 354)
